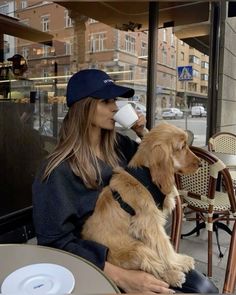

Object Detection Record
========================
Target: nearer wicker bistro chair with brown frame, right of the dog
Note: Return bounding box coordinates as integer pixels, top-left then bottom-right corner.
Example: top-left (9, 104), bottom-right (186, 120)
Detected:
top-left (176, 147), bottom-right (236, 277)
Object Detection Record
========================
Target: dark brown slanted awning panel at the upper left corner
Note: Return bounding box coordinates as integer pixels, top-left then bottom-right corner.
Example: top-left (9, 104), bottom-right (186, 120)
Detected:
top-left (0, 14), bottom-right (53, 46)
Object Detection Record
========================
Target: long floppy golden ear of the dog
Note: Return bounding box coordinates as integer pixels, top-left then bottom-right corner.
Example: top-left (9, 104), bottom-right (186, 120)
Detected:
top-left (149, 143), bottom-right (174, 195)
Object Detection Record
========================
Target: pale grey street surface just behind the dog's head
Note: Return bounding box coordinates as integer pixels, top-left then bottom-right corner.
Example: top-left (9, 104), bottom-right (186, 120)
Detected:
top-left (156, 117), bottom-right (206, 146)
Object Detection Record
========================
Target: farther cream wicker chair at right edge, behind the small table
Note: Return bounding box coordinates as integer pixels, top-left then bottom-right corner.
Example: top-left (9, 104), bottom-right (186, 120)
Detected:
top-left (208, 132), bottom-right (236, 191)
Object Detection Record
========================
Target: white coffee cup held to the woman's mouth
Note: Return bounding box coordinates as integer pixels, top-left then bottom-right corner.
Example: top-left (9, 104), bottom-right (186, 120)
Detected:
top-left (114, 103), bottom-right (138, 129)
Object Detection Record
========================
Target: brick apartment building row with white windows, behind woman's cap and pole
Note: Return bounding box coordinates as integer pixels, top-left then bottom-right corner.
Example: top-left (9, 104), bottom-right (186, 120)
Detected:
top-left (2, 0), bottom-right (208, 112)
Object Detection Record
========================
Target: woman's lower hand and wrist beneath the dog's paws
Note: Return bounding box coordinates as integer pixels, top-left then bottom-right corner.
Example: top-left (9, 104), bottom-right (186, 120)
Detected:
top-left (104, 262), bottom-right (175, 294)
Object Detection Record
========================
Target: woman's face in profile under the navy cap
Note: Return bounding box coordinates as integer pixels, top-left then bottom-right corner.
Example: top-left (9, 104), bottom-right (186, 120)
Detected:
top-left (92, 99), bottom-right (118, 130)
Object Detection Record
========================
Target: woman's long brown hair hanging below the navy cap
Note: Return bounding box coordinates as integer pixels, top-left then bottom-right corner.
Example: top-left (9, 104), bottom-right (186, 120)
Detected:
top-left (43, 97), bottom-right (118, 189)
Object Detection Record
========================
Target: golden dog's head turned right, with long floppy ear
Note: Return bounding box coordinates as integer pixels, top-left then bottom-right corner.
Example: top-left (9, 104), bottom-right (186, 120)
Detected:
top-left (130, 123), bottom-right (200, 194)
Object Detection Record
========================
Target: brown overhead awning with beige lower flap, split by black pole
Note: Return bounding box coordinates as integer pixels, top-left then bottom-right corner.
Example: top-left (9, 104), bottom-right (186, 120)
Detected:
top-left (54, 0), bottom-right (210, 54)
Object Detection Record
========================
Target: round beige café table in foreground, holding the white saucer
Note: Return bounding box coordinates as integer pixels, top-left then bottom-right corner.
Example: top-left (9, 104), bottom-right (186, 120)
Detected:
top-left (0, 244), bottom-right (120, 294)
